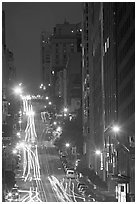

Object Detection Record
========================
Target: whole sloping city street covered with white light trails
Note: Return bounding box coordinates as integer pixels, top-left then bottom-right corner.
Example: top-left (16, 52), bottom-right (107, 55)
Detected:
top-left (16, 99), bottom-right (84, 202)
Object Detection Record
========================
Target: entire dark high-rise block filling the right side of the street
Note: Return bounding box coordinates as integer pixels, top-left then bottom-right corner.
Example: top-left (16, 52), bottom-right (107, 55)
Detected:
top-left (82, 2), bottom-right (135, 201)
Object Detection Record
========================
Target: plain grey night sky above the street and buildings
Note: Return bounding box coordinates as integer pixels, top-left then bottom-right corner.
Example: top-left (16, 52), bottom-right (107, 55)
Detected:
top-left (2, 2), bottom-right (82, 94)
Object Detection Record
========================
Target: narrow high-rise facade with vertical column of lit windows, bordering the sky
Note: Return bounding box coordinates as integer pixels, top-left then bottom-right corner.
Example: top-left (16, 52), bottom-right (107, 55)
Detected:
top-left (82, 3), bottom-right (103, 171)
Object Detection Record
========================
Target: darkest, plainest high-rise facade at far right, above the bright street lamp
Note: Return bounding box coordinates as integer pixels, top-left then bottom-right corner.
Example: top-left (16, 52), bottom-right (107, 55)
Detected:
top-left (116, 3), bottom-right (135, 144)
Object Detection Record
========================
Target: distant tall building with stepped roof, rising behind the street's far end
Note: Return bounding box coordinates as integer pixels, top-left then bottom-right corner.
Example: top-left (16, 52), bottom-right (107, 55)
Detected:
top-left (42, 20), bottom-right (81, 111)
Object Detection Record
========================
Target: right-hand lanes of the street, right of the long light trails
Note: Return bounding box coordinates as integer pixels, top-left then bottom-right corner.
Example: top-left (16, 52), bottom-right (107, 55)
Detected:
top-left (35, 113), bottom-right (84, 202)
